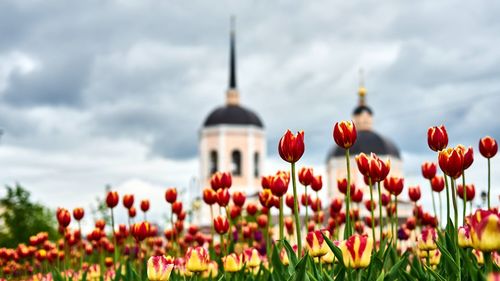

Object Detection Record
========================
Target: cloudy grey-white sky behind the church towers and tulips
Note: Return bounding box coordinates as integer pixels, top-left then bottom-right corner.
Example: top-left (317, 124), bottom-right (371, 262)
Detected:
top-left (0, 0), bottom-right (500, 226)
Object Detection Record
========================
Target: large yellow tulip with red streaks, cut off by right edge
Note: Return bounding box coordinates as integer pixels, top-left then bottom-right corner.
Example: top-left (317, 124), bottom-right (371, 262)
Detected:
top-left (469, 210), bottom-right (500, 252)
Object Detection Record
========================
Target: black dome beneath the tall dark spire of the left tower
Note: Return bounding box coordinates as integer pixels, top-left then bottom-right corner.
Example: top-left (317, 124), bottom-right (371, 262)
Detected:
top-left (203, 105), bottom-right (264, 128)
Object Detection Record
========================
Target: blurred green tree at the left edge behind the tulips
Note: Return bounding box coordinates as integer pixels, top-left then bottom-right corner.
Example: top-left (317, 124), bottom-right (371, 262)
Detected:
top-left (0, 184), bottom-right (59, 247)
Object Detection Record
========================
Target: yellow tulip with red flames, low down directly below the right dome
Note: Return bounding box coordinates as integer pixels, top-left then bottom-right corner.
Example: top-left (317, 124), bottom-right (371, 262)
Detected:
top-left (340, 234), bottom-right (373, 269)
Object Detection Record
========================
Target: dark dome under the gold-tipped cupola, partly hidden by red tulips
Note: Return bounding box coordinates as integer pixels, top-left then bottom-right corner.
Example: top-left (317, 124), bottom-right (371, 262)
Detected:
top-left (328, 131), bottom-right (401, 159)
